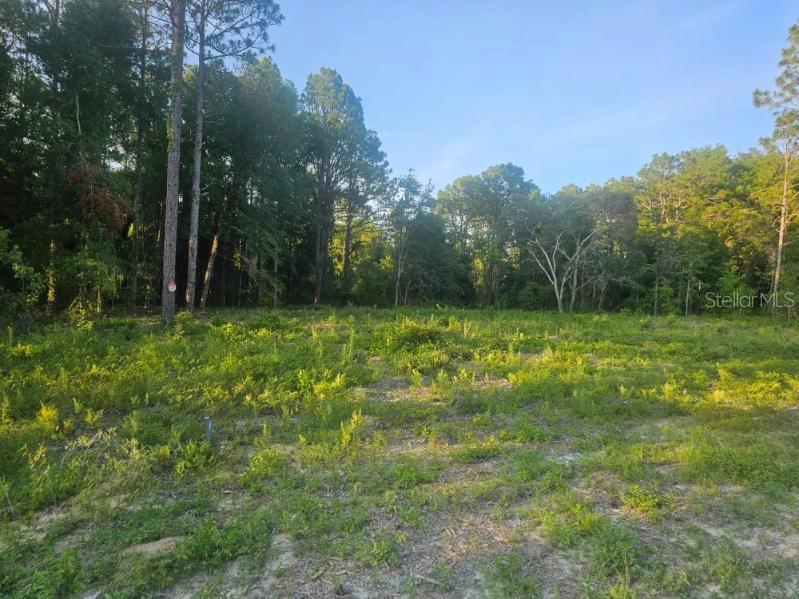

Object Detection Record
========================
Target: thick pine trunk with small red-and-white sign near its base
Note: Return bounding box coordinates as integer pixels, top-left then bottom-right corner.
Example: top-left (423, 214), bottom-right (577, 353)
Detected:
top-left (161, 0), bottom-right (186, 325)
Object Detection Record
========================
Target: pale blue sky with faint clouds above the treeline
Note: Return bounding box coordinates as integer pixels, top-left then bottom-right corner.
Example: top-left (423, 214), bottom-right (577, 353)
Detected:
top-left (272, 0), bottom-right (799, 191)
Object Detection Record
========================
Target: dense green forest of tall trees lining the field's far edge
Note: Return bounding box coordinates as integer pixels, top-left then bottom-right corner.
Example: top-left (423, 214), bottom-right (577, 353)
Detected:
top-left (0, 0), bottom-right (799, 322)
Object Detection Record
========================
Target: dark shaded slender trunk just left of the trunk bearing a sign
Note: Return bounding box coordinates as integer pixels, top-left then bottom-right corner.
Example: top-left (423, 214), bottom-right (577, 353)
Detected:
top-left (130, 4), bottom-right (149, 310)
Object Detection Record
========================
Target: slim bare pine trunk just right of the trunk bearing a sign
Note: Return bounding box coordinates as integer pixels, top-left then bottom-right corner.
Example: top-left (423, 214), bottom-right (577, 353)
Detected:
top-left (186, 15), bottom-right (205, 312)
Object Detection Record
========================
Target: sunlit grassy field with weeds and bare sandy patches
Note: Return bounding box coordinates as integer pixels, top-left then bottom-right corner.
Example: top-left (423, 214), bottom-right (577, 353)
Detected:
top-left (0, 309), bottom-right (799, 597)
